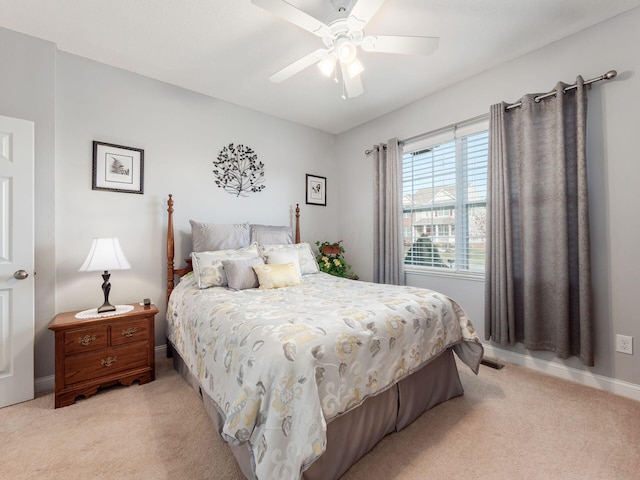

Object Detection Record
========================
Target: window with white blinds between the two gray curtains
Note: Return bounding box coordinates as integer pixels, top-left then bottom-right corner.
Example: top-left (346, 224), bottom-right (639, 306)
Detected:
top-left (402, 119), bottom-right (489, 274)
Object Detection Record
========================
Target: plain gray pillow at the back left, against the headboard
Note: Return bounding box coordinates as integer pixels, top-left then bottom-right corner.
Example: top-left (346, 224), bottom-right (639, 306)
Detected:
top-left (189, 220), bottom-right (250, 252)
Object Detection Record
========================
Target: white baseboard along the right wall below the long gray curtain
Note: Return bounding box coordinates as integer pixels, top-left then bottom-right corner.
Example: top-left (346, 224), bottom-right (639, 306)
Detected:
top-left (482, 343), bottom-right (640, 401)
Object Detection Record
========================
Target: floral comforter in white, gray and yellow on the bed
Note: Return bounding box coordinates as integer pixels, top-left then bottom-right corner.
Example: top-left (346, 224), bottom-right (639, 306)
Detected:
top-left (167, 273), bottom-right (482, 479)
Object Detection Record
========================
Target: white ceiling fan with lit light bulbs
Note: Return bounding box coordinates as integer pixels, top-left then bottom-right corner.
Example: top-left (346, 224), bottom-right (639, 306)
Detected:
top-left (251, 0), bottom-right (439, 98)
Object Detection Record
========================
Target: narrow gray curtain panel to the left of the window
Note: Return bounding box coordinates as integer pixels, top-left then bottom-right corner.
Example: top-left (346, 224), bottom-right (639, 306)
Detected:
top-left (371, 138), bottom-right (404, 285)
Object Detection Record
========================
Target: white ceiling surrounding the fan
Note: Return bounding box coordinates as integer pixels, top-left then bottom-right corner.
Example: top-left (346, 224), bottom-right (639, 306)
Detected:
top-left (0, 0), bottom-right (640, 134)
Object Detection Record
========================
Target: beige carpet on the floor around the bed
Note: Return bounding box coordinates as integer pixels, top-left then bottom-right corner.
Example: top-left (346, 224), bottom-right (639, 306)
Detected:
top-left (0, 359), bottom-right (640, 480)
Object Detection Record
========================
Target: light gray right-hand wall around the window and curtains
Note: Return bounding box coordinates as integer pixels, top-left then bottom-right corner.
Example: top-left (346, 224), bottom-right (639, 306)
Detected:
top-left (337, 8), bottom-right (640, 385)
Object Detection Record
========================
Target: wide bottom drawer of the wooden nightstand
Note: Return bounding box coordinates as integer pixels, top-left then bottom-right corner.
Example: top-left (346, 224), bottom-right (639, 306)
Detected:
top-left (64, 342), bottom-right (148, 384)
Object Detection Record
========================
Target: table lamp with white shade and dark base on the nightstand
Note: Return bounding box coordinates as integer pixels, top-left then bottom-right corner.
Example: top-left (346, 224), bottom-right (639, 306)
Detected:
top-left (78, 238), bottom-right (131, 313)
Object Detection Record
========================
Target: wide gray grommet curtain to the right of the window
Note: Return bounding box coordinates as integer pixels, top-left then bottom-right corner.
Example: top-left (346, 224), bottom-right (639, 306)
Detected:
top-left (485, 77), bottom-right (593, 366)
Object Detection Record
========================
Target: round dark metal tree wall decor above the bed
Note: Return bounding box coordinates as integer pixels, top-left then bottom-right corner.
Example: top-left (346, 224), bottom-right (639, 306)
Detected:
top-left (213, 143), bottom-right (265, 197)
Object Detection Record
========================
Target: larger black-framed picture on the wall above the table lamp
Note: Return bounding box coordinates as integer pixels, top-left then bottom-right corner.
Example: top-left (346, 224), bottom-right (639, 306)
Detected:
top-left (93, 141), bottom-right (144, 194)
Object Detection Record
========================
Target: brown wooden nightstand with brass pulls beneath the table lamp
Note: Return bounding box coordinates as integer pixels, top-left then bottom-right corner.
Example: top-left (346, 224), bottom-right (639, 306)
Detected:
top-left (49, 304), bottom-right (158, 408)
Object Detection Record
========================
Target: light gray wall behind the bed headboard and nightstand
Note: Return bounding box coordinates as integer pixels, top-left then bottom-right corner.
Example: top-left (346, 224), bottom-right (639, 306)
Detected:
top-left (55, 52), bottom-right (338, 368)
